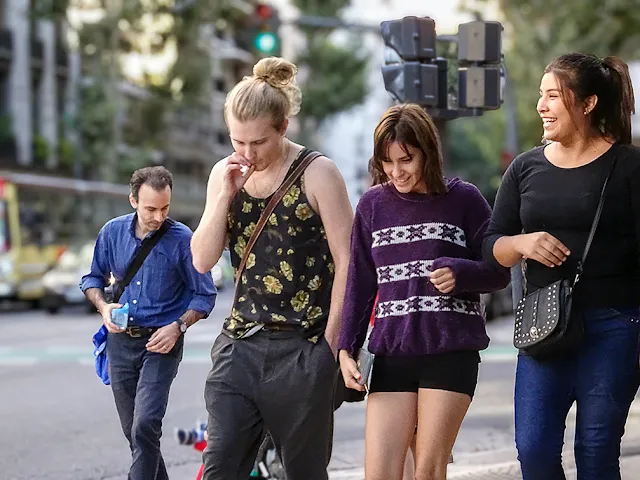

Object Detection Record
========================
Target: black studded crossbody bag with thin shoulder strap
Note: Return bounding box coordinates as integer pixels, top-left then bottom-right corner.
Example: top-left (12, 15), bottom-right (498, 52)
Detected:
top-left (513, 157), bottom-right (617, 357)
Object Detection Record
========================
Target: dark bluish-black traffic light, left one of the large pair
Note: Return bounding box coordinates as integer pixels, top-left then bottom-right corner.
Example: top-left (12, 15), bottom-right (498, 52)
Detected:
top-left (380, 17), bottom-right (439, 106)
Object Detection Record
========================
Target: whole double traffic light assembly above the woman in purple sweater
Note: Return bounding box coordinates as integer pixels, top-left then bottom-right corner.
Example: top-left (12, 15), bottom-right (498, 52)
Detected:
top-left (380, 17), bottom-right (503, 119)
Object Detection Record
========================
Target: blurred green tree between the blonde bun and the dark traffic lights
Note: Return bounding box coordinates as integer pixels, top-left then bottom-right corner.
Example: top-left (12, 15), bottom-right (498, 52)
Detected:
top-left (292, 0), bottom-right (369, 144)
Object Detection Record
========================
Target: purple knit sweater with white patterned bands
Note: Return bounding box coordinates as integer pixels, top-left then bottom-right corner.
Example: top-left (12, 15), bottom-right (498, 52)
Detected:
top-left (338, 178), bottom-right (509, 356)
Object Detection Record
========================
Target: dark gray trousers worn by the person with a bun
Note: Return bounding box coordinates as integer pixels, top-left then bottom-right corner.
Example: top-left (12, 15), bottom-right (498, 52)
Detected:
top-left (203, 330), bottom-right (337, 480)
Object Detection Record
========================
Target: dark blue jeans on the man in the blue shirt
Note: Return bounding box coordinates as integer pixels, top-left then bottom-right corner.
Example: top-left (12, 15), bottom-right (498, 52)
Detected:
top-left (107, 333), bottom-right (184, 480)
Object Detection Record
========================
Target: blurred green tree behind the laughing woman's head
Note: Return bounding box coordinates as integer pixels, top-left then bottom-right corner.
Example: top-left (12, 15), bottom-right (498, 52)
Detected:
top-left (462, 0), bottom-right (640, 149)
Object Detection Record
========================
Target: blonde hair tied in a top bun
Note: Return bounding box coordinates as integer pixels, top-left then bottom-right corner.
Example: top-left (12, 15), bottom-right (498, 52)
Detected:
top-left (224, 57), bottom-right (302, 130)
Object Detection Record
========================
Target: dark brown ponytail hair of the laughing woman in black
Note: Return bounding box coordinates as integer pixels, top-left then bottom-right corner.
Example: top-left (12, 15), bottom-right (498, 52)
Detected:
top-left (544, 53), bottom-right (635, 143)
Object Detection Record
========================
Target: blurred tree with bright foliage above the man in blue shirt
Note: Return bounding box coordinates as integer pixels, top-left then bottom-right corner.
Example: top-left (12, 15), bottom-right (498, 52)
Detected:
top-left (53, 0), bottom-right (232, 181)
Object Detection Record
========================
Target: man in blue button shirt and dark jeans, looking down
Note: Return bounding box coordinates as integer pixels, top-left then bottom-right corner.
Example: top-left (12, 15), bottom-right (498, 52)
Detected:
top-left (80, 167), bottom-right (216, 480)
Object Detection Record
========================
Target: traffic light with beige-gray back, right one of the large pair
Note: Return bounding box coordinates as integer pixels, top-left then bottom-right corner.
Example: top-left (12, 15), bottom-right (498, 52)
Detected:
top-left (458, 21), bottom-right (503, 110)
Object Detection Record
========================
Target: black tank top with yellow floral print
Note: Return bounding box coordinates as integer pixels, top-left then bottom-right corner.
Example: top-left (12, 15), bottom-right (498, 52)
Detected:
top-left (223, 149), bottom-right (334, 341)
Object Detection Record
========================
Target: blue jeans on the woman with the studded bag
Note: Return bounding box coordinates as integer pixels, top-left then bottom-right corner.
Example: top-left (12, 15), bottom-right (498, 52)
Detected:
top-left (515, 308), bottom-right (640, 480)
